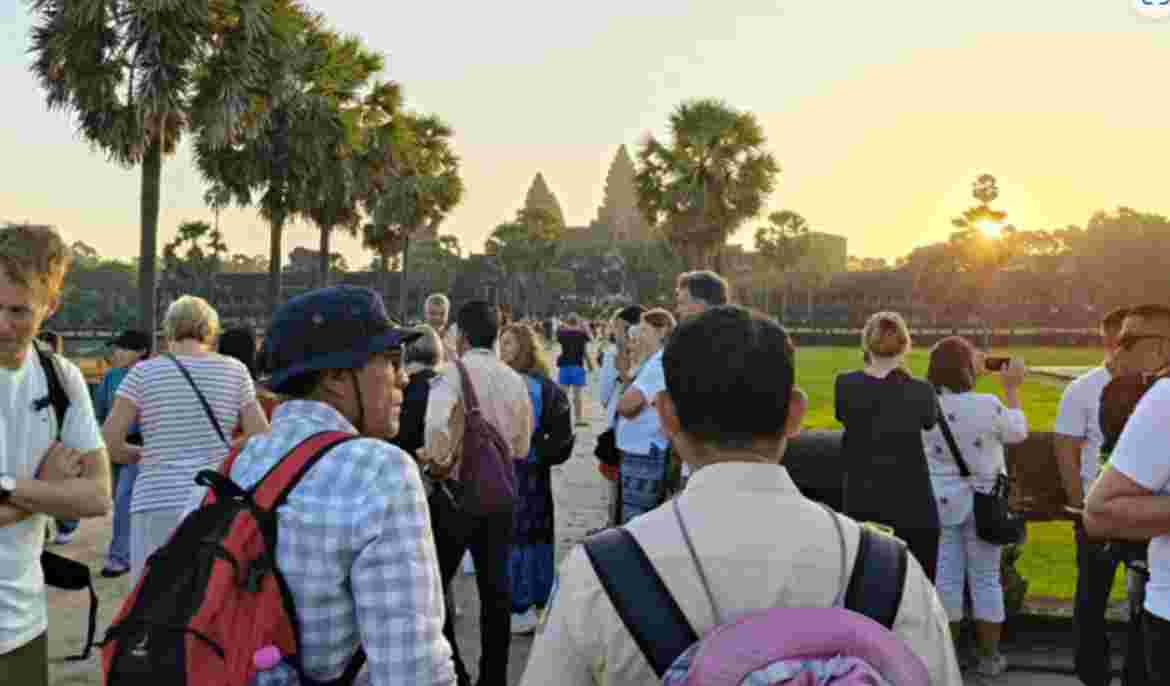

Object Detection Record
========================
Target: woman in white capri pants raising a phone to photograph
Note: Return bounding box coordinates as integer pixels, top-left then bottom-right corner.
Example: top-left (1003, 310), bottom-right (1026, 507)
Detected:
top-left (922, 336), bottom-right (1027, 677)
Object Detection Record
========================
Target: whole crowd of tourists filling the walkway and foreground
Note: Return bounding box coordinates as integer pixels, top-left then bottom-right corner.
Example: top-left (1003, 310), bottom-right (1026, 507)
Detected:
top-left (0, 221), bottom-right (1170, 686)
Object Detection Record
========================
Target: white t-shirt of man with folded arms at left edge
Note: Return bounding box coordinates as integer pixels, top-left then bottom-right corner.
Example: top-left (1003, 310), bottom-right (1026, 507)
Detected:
top-left (0, 347), bottom-right (105, 654)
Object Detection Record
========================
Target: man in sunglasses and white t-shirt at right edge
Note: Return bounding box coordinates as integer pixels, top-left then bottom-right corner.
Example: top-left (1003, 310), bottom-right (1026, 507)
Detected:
top-left (1085, 304), bottom-right (1170, 684)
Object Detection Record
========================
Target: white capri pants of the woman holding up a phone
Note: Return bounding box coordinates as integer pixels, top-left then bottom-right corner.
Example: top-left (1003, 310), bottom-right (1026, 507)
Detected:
top-left (935, 512), bottom-right (1004, 624)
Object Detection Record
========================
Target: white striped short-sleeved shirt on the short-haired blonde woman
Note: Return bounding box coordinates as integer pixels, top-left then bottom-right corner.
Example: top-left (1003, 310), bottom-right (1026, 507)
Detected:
top-left (118, 355), bottom-right (256, 513)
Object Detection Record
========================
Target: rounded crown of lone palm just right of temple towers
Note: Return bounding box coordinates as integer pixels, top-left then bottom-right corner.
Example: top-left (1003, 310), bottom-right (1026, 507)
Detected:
top-left (634, 100), bottom-right (779, 268)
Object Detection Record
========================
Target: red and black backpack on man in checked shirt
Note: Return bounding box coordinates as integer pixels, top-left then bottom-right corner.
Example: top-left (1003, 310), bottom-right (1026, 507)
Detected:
top-left (102, 432), bottom-right (365, 686)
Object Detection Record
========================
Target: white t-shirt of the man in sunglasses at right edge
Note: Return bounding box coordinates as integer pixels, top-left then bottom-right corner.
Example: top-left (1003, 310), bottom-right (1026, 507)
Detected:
top-left (1109, 379), bottom-right (1170, 620)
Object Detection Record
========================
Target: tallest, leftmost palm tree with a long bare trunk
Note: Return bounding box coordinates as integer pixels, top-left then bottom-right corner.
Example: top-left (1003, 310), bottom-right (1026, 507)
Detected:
top-left (29, 0), bottom-right (276, 331)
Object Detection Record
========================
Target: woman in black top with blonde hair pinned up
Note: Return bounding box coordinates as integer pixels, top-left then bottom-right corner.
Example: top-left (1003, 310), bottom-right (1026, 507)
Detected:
top-left (834, 313), bottom-right (941, 581)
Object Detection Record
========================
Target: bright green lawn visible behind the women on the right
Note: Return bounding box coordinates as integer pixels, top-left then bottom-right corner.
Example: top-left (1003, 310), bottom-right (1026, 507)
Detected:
top-left (797, 348), bottom-right (1124, 599)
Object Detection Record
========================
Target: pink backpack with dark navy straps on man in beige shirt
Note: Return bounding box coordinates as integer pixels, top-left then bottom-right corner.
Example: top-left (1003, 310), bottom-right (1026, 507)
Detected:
top-left (585, 500), bottom-right (930, 686)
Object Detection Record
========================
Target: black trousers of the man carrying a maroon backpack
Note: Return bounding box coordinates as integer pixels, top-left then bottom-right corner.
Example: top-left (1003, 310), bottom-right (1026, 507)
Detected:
top-left (431, 479), bottom-right (512, 686)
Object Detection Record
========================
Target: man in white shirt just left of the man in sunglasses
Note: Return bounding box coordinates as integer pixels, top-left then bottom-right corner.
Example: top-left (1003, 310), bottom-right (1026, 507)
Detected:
top-left (1053, 308), bottom-right (1136, 686)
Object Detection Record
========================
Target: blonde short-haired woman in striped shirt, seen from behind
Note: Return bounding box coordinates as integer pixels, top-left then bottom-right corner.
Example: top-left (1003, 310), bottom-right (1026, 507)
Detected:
top-left (102, 295), bottom-right (268, 583)
